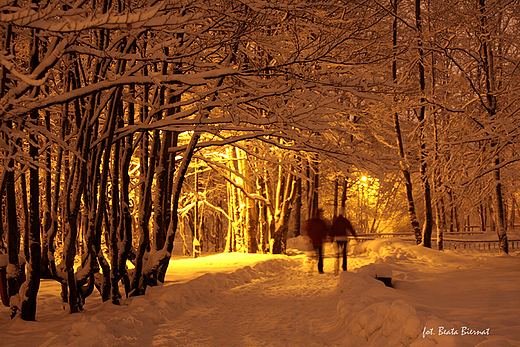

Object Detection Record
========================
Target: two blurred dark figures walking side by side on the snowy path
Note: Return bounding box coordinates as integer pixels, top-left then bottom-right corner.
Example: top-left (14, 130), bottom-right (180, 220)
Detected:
top-left (305, 208), bottom-right (357, 273)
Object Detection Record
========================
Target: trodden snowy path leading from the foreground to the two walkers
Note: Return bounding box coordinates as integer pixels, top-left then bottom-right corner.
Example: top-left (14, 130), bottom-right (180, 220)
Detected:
top-left (154, 256), bottom-right (338, 347)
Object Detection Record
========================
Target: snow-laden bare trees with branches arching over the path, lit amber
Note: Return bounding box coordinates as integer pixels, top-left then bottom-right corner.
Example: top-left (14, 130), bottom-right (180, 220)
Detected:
top-left (0, 0), bottom-right (520, 320)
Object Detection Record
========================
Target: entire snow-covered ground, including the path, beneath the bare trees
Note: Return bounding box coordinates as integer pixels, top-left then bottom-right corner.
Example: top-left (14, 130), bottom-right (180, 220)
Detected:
top-left (0, 237), bottom-right (520, 347)
